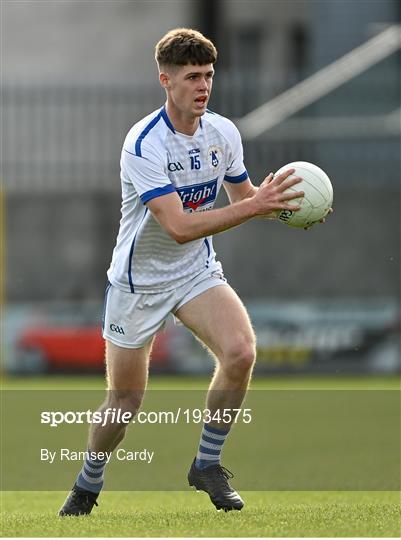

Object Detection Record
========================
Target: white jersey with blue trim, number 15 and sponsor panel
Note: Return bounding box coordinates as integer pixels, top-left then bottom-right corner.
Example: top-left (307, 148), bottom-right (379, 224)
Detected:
top-left (107, 107), bottom-right (248, 293)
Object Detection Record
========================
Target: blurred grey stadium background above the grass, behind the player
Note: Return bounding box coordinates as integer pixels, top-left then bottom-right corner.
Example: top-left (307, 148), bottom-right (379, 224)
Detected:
top-left (2, 0), bottom-right (400, 374)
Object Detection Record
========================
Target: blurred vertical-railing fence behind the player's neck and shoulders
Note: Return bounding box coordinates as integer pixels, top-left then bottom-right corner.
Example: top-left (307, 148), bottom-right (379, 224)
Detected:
top-left (2, 62), bottom-right (399, 193)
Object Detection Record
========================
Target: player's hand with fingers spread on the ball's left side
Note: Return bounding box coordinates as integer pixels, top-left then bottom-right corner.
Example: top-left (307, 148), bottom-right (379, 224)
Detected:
top-left (252, 169), bottom-right (304, 218)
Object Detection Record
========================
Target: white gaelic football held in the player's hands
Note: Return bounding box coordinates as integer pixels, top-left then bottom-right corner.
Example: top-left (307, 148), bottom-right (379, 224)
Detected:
top-left (275, 161), bottom-right (333, 228)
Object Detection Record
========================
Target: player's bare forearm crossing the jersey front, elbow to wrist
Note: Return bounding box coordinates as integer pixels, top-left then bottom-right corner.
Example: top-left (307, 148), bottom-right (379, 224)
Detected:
top-left (172, 198), bottom-right (256, 244)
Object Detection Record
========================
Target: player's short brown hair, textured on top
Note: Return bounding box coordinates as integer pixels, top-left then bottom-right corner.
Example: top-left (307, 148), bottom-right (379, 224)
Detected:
top-left (155, 28), bottom-right (217, 67)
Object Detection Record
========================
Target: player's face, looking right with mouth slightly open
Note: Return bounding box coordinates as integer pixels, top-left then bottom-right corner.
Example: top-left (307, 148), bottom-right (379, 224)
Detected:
top-left (164, 64), bottom-right (214, 118)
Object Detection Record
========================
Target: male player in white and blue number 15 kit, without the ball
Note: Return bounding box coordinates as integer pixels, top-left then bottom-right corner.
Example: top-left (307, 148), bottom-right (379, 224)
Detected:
top-left (60, 28), bottom-right (303, 515)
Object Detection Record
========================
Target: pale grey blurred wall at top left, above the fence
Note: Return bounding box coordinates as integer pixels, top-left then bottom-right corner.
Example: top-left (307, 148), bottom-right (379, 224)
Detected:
top-left (2, 0), bottom-right (191, 84)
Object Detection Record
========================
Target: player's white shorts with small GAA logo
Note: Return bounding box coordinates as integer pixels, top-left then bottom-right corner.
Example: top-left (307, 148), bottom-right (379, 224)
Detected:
top-left (103, 268), bottom-right (227, 349)
